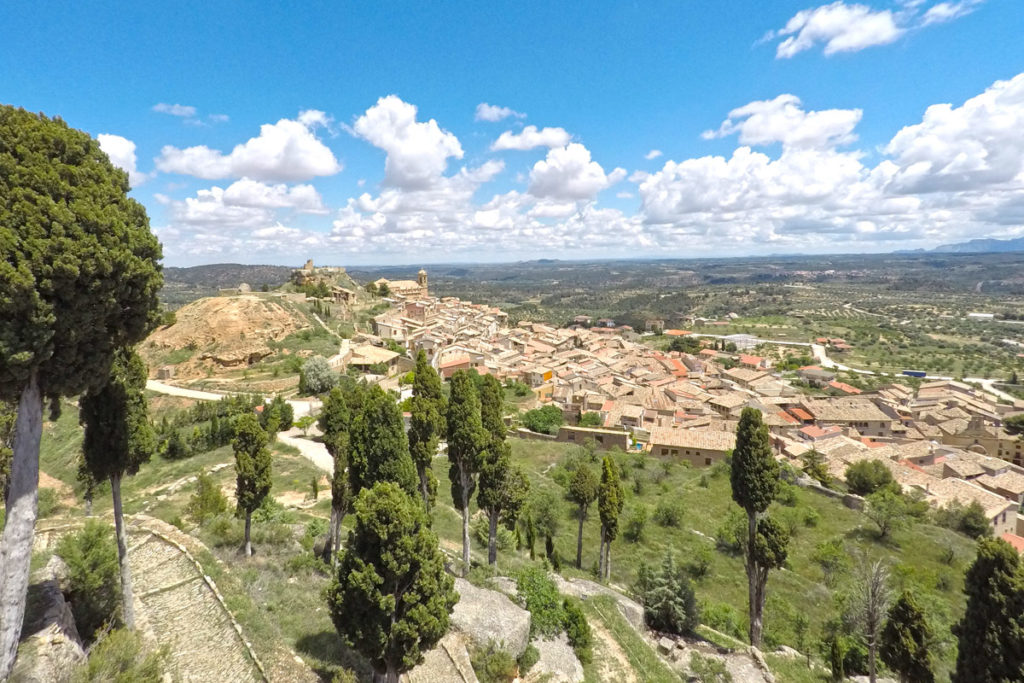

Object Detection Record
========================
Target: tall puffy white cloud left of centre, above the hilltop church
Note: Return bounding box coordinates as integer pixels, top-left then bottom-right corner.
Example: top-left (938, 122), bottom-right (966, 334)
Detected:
top-left (352, 95), bottom-right (463, 189)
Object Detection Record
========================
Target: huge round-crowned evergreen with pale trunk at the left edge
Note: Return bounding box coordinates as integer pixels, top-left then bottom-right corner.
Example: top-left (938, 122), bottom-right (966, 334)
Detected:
top-left (0, 105), bottom-right (163, 680)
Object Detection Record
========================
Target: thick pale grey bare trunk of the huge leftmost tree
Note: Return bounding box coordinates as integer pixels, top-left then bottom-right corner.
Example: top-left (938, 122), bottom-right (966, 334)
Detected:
top-left (0, 372), bottom-right (43, 681)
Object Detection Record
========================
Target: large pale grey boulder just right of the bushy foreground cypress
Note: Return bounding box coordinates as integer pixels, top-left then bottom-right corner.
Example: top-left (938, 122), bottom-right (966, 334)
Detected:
top-left (452, 579), bottom-right (529, 658)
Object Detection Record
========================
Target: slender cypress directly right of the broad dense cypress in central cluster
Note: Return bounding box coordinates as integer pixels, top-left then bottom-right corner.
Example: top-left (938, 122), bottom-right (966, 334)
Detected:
top-left (409, 349), bottom-right (447, 512)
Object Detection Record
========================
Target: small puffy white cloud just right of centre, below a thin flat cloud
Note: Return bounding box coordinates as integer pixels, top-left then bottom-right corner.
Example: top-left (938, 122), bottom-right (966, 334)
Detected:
top-left (528, 142), bottom-right (626, 200)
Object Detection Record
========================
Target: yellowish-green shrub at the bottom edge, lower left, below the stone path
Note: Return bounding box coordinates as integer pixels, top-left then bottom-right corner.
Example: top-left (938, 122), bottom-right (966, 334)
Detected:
top-left (72, 629), bottom-right (167, 683)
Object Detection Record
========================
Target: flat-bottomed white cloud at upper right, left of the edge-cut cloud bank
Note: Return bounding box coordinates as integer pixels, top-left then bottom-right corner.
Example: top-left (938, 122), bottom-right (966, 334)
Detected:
top-left (702, 94), bottom-right (863, 147)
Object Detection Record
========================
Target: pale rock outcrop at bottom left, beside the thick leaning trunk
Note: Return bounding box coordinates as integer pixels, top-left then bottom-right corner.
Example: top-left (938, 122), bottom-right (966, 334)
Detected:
top-left (11, 556), bottom-right (85, 683)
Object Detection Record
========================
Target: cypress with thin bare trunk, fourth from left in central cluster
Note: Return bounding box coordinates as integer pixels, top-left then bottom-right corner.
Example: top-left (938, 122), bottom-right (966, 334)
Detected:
top-left (447, 370), bottom-right (488, 570)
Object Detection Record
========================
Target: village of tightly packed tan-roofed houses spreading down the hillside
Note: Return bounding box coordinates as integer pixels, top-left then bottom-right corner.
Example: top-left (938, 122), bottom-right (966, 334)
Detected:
top-left (351, 271), bottom-right (1024, 550)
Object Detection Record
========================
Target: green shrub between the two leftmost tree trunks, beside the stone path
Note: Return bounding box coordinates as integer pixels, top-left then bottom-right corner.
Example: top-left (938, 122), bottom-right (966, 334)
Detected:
top-left (57, 519), bottom-right (121, 641)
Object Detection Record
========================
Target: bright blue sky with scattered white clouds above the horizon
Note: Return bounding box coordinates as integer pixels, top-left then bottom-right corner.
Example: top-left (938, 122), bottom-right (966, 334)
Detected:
top-left (0, 0), bottom-right (1024, 265)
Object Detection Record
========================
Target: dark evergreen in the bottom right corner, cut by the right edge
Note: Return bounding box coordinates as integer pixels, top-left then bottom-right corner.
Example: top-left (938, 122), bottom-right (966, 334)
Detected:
top-left (952, 539), bottom-right (1024, 683)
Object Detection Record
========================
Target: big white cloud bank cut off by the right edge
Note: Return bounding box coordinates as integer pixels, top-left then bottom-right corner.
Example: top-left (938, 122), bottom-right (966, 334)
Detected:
top-left (885, 74), bottom-right (1024, 193)
